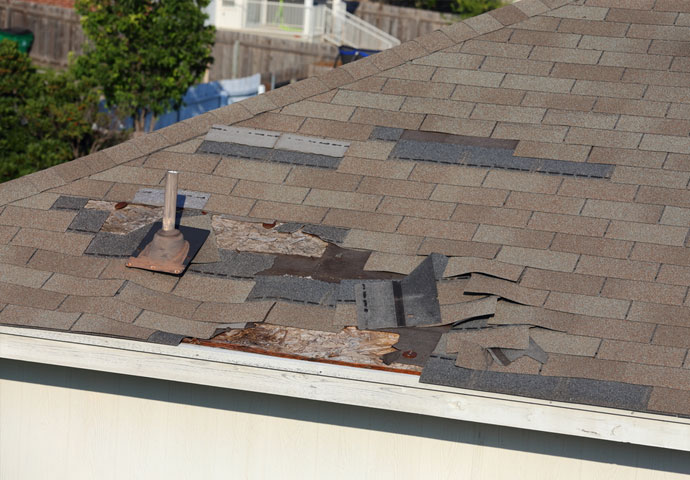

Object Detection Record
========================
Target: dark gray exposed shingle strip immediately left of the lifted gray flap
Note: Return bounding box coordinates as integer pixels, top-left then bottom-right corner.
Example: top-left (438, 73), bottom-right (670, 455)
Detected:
top-left (247, 275), bottom-right (338, 307)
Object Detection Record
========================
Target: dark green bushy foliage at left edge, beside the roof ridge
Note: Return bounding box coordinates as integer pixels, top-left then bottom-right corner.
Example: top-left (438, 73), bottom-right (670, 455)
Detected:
top-left (0, 40), bottom-right (123, 182)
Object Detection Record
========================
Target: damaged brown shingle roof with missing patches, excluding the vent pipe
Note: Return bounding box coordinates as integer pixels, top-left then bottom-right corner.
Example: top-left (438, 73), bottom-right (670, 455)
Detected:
top-left (0, 0), bottom-right (690, 417)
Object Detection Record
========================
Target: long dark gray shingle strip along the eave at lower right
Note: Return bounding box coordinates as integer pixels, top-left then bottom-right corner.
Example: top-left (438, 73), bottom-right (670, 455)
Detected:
top-left (419, 354), bottom-right (651, 411)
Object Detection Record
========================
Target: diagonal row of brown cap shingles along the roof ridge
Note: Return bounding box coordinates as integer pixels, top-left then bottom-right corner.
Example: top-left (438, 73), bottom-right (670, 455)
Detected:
top-left (0, 0), bottom-right (579, 206)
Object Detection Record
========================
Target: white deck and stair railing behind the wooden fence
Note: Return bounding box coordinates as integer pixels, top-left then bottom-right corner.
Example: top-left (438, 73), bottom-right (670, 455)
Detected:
top-left (236, 0), bottom-right (400, 50)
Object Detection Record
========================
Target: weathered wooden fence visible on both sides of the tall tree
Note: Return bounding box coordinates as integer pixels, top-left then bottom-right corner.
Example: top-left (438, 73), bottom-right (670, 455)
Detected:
top-left (0, 0), bottom-right (337, 85)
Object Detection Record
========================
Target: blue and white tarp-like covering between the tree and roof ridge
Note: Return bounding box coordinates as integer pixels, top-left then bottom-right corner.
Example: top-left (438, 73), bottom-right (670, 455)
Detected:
top-left (115, 73), bottom-right (262, 130)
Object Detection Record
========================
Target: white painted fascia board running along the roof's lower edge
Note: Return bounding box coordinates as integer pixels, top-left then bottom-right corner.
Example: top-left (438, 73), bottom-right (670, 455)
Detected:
top-left (0, 326), bottom-right (690, 451)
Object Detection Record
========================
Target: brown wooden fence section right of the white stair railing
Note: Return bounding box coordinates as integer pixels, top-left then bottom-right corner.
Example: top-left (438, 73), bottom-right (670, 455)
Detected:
top-left (355, 1), bottom-right (460, 42)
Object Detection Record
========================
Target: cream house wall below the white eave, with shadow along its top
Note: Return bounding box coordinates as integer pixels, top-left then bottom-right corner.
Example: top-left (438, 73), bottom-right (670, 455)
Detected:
top-left (0, 360), bottom-right (690, 480)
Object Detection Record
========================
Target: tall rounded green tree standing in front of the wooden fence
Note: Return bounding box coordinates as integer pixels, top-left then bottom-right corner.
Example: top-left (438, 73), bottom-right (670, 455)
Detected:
top-left (75, 0), bottom-right (215, 132)
